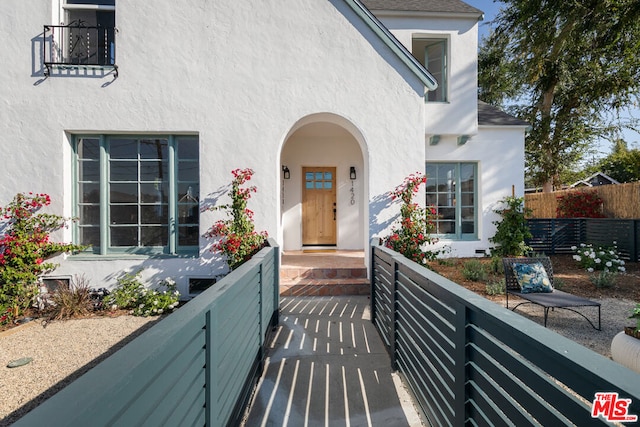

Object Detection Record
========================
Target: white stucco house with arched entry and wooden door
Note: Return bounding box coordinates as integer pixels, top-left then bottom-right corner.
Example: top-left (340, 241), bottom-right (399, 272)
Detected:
top-left (0, 0), bottom-right (527, 294)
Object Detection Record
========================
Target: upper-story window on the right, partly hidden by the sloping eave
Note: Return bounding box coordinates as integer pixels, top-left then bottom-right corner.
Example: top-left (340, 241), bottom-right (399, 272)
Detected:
top-left (411, 37), bottom-right (449, 102)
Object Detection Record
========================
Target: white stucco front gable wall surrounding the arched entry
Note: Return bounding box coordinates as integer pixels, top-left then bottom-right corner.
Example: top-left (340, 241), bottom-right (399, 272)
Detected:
top-left (0, 0), bottom-right (425, 294)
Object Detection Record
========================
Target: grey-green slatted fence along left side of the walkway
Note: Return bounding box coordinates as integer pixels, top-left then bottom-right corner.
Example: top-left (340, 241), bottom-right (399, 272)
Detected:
top-left (14, 239), bottom-right (279, 427)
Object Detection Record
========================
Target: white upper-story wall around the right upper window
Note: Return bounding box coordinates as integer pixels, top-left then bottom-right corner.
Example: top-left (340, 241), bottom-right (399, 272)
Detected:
top-left (370, 15), bottom-right (478, 135)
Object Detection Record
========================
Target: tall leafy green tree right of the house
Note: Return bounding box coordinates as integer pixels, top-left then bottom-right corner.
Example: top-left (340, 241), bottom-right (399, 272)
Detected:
top-left (478, 0), bottom-right (640, 191)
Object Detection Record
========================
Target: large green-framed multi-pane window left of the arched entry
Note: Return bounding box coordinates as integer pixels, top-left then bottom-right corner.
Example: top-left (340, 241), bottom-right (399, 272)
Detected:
top-left (74, 135), bottom-right (199, 254)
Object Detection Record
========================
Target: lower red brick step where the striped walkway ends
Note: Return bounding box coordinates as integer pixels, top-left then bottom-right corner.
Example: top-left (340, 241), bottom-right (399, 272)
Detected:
top-left (280, 277), bottom-right (371, 296)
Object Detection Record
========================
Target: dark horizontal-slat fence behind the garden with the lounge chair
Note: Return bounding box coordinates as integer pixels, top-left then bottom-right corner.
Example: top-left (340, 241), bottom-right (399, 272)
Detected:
top-left (526, 218), bottom-right (640, 262)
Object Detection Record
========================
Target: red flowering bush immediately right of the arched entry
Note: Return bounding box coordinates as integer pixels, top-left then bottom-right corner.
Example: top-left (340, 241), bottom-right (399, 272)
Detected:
top-left (384, 173), bottom-right (438, 264)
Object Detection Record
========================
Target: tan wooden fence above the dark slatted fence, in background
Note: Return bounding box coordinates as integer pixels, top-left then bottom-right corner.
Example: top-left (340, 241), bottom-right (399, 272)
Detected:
top-left (524, 182), bottom-right (640, 219)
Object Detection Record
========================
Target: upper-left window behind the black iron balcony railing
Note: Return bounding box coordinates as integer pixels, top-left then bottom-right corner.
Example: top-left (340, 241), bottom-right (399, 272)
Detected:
top-left (62, 0), bottom-right (116, 65)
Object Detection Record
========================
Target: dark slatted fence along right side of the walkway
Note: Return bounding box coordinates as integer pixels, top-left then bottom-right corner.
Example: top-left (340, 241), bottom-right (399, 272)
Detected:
top-left (371, 241), bottom-right (640, 426)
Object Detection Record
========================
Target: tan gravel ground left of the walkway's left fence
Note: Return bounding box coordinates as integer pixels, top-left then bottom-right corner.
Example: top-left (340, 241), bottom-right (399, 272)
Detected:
top-left (0, 316), bottom-right (158, 427)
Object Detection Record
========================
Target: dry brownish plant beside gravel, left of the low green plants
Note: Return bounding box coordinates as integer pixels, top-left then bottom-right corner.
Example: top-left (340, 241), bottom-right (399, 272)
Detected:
top-left (50, 276), bottom-right (93, 320)
